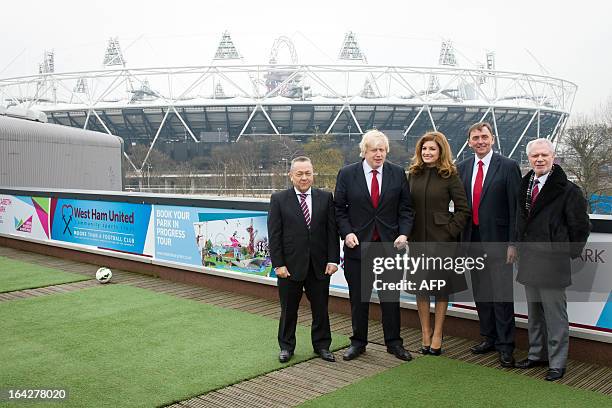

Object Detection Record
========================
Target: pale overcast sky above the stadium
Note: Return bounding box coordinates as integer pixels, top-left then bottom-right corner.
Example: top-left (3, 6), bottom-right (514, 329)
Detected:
top-left (0, 0), bottom-right (612, 114)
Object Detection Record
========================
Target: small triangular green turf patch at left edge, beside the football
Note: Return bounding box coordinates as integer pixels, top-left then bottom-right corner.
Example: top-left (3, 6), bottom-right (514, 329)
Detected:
top-left (0, 256), bottom-right (91, 293)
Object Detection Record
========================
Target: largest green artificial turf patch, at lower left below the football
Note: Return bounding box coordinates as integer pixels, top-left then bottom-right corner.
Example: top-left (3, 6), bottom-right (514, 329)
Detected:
top-left (0, 285), bottom-right (348, 407)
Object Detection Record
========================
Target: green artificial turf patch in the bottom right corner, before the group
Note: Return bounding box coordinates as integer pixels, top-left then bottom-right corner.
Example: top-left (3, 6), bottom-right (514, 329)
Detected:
top-left (301, 356), bottom-right (612, 408)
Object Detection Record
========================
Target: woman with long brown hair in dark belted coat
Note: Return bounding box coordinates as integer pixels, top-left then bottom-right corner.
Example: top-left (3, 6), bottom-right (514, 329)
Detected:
top-left (409, 132), bottom-right (470, 356)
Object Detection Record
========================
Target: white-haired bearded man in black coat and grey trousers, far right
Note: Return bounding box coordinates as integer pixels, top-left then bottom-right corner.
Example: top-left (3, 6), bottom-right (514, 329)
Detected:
top-left (516, 139), bottom-right (591, 381)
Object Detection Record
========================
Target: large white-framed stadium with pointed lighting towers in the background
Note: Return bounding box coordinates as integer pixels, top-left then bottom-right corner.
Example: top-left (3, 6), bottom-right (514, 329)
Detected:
top-left (0, 32), bottom-right (577, 170)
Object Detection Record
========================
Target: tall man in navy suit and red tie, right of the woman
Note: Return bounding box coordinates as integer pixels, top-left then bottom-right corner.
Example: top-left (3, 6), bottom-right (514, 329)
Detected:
top-left (457, 122), bottom-right (521, 367)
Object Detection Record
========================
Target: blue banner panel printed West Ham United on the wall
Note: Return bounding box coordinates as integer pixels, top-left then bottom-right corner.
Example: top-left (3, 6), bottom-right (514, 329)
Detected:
top-left (50, 198), bottom-right (153, 256)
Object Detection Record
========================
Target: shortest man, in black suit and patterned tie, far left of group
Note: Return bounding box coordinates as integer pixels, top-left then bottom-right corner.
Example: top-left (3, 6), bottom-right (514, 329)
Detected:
top-left (268, 157), bottom-right (340, 363)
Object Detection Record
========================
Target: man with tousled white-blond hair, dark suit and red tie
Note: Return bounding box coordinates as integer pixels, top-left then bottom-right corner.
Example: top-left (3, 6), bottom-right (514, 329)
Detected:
top-left (335, 130), bottom-right (414, 361)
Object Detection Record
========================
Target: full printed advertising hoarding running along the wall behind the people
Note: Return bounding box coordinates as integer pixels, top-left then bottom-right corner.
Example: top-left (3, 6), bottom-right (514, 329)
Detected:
top-left (0, 190), bottom-right (612, 333)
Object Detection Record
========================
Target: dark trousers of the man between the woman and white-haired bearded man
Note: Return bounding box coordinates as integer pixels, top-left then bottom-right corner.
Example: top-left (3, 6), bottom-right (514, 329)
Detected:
top-left (470, 226), bottom-right (515, 353)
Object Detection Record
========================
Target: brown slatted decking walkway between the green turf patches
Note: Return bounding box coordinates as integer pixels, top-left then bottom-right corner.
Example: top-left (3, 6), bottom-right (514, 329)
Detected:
top-left (0, 247), bottom-right (612, 407)
